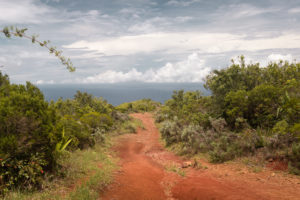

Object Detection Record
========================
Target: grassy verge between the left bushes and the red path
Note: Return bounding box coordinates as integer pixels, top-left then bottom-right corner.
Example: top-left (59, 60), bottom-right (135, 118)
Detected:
top-left (3, 143), bottom-right (117, 200)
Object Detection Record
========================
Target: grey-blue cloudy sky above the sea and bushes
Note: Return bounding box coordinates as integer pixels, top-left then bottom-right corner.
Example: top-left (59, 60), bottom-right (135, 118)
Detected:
top-left (0, 0), bottom-right (300, 84)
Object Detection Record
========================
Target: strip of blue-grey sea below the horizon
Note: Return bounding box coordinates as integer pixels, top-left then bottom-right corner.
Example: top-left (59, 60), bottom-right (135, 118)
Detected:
top-left (38, 83), bottom-right (209, 105)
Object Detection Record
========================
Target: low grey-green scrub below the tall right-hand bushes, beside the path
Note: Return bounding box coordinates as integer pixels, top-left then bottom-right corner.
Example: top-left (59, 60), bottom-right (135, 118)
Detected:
top-left (160, 119), bottom-right (261, 162)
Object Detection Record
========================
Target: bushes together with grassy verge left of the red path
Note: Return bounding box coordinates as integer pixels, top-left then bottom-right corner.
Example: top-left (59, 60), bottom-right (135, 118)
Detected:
top-left (0, 72), bottom-right (140, 199)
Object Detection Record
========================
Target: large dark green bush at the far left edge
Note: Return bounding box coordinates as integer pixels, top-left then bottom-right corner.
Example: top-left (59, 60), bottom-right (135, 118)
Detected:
top-left (0, 73), bottom-right (59, 193)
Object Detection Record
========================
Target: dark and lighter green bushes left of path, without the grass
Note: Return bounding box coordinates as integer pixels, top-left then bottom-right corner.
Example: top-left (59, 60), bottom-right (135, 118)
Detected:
top-left (0, 72), bottom-right (129, 195)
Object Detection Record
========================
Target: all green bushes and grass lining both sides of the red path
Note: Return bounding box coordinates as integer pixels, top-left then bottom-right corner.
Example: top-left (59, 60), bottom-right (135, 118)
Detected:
top-left (0, 57), bottom-right (300, 199)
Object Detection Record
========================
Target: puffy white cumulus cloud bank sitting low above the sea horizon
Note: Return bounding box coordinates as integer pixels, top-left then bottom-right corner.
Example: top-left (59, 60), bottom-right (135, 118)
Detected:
top-left (79, 53), bottom-right (210, 83)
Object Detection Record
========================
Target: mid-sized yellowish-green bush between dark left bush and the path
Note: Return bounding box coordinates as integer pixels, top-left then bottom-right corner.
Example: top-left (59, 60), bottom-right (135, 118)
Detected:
top-left (51, 91), bottom-right (117, 149)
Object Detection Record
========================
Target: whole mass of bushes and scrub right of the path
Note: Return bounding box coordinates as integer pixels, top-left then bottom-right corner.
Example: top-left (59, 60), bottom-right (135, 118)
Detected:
top-left (156, 56), bottom-right (300, 175)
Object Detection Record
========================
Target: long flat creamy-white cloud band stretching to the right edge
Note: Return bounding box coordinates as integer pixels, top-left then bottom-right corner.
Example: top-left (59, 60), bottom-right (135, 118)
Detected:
top-left (64, 32), bottom-right (300, 56)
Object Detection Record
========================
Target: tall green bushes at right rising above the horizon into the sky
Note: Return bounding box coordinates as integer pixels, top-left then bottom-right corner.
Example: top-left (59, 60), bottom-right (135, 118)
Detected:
top-left (205, 56), bottom-right (300, 128)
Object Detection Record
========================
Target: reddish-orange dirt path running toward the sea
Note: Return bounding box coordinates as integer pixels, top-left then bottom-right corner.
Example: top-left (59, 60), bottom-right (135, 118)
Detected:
top-left (101, 113), bottom-right (300, 200)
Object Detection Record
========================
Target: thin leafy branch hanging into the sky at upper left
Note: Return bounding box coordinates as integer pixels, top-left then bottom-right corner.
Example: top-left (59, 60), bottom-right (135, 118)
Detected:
top-left (0, 26), bottom-right (76, 72)
